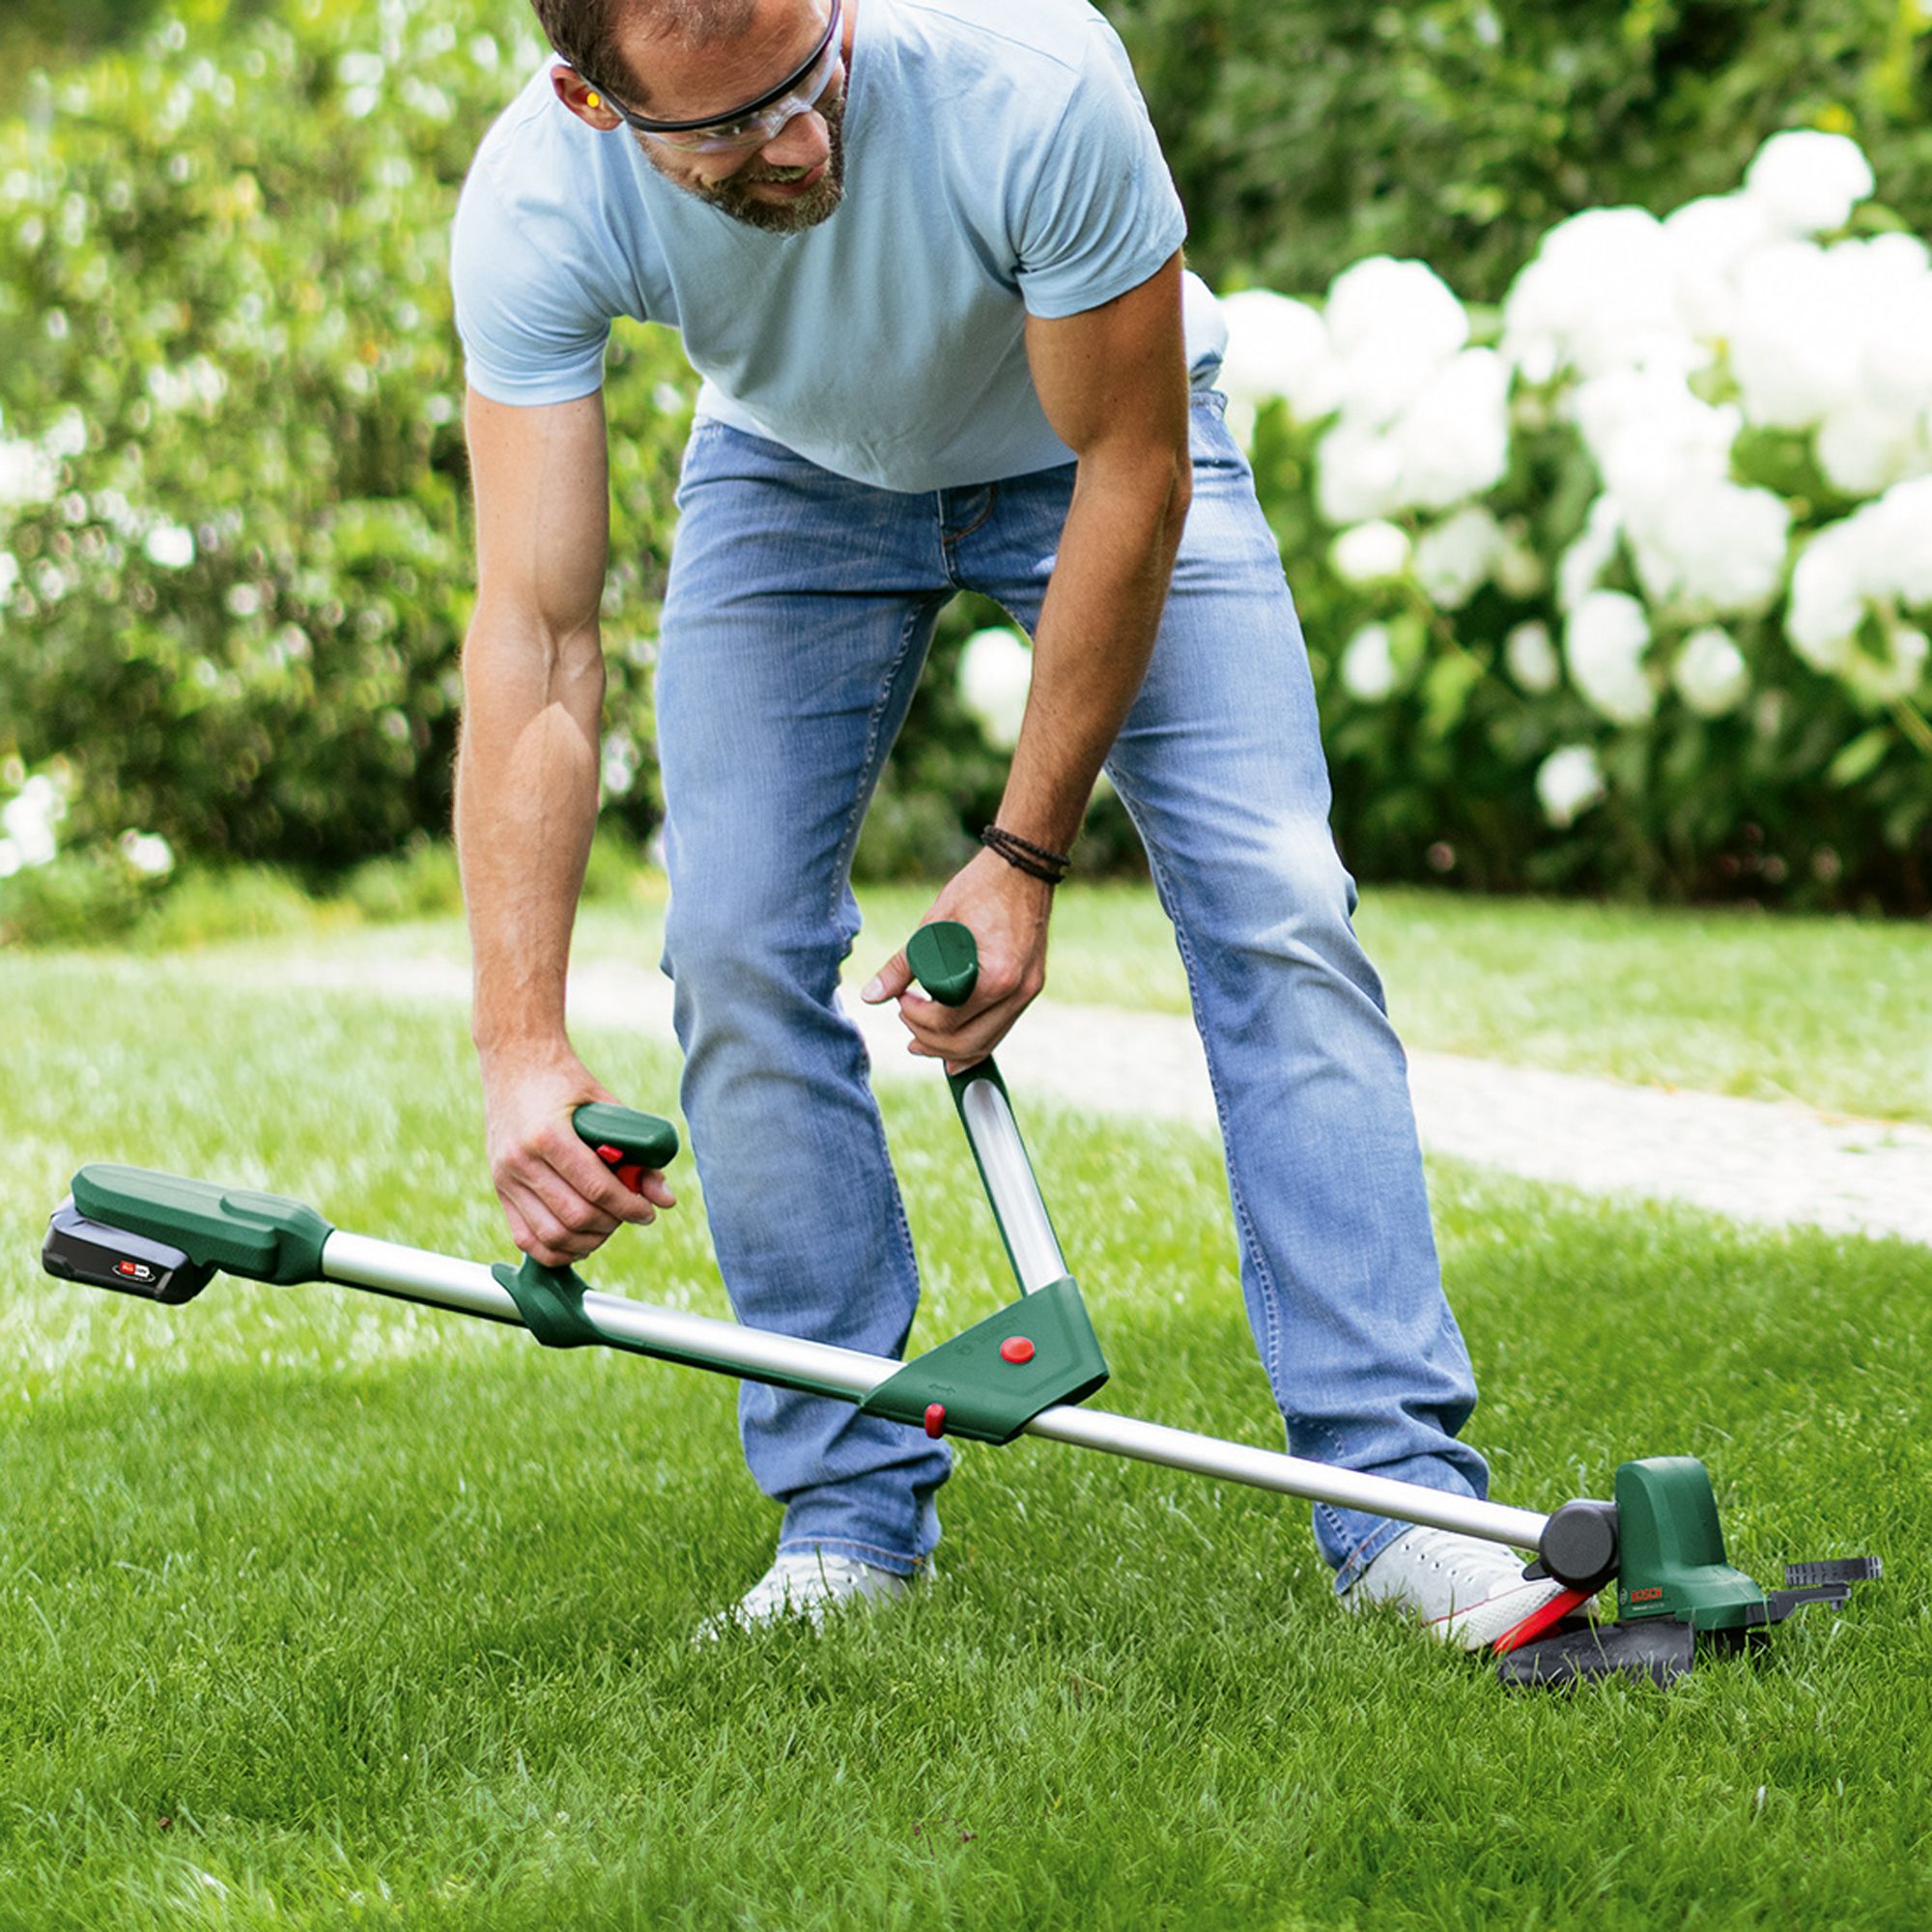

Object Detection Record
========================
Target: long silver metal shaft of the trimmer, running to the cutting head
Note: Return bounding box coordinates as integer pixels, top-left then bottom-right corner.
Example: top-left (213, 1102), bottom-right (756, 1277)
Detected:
top-left (323, 1236), bottom-right (1546, 1549)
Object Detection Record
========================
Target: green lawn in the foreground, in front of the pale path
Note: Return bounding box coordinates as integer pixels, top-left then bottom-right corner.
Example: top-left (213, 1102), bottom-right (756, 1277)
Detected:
top-left (0, 956), bottom-right (1932, 1932)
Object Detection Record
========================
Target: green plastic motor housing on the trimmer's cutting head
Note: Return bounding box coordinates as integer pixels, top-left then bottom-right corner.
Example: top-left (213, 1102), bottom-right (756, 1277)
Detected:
top-left (1617, 1455), bottom-right (1764, 1631)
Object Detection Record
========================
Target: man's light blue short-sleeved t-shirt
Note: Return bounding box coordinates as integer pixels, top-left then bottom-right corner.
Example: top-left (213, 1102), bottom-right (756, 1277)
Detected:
top-left (450, 0), bottom-right (1223, 491)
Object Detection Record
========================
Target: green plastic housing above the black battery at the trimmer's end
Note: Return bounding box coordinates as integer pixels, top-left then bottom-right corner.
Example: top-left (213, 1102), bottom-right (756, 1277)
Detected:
top-left (73, 1161), bottom-right (334, 1287)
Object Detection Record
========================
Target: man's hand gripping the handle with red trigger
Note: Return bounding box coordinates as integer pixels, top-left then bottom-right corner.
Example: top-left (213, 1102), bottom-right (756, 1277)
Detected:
top-left (483, 1047), bottom-right (676, 1267)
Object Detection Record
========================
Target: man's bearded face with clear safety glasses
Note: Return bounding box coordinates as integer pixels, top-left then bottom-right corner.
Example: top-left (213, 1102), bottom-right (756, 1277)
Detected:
top-left (556, 0), bottom-right (852, 234)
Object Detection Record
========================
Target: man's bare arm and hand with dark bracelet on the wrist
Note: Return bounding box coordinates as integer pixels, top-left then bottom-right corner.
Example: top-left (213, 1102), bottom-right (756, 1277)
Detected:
top-left (866, 255), bottom-right (1192, 1066)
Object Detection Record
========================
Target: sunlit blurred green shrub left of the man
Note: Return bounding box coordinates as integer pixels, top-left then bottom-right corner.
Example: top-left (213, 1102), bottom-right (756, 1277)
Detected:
top-left (0, 4), bottom-right (692, 871)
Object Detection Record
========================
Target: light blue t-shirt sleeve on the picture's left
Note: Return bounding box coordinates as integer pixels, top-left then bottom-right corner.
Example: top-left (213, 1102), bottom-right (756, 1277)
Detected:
top-left (450, 146), bottom-right (611, 406)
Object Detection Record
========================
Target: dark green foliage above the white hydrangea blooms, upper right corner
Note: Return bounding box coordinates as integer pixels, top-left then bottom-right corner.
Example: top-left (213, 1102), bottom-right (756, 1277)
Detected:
top-left (1101, 0), bottom-right (1932, 301)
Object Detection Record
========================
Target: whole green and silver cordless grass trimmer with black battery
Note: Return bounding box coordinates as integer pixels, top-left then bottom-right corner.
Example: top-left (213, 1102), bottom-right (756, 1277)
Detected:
top-left (43, 922), bottom-right (1880, 1685)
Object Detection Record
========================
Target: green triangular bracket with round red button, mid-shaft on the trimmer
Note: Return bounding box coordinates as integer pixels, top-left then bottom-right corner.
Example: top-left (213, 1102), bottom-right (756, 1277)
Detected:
top-left (860, 1275), bottom-right (1107, 1443)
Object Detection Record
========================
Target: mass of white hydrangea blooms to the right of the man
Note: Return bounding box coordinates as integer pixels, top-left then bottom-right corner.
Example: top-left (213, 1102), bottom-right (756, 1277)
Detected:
top-left (1223, 131), bottom-right (1932, 825)
